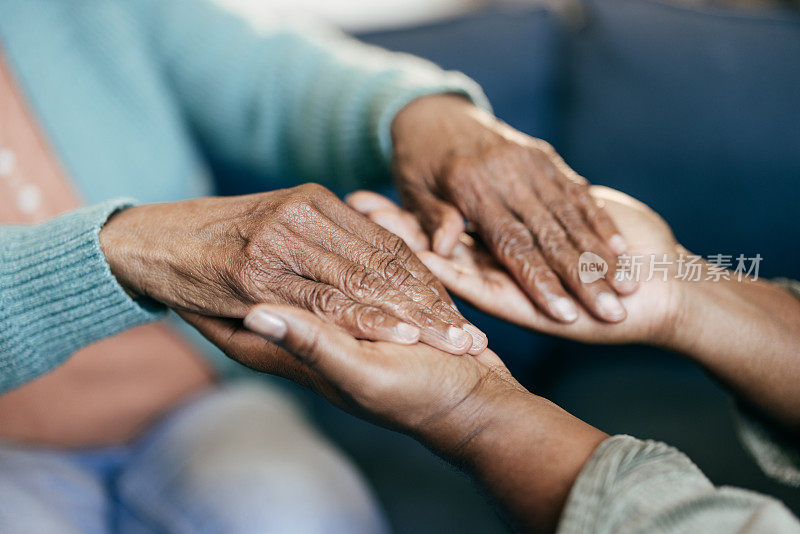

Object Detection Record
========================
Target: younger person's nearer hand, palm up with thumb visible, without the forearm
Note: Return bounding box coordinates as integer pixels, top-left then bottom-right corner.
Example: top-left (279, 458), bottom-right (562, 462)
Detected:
top-left (178, 307), bottom-right (522, 440)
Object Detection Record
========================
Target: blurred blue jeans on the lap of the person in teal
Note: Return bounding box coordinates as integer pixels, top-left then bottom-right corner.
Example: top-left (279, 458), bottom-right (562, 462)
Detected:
top-left (0, 383), bottom-right (387, 534)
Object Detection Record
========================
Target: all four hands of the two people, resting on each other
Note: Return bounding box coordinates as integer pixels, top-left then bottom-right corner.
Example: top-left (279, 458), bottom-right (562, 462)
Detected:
top-left (100, 95), bottom-right (674, 456)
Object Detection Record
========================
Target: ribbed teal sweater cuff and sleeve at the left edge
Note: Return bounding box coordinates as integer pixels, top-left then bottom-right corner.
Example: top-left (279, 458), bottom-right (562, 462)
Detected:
top-left (0, 199), bottom-right (161, 393)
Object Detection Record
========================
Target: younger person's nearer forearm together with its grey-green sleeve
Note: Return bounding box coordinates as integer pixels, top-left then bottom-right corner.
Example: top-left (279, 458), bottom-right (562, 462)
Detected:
top-left (423, 378), bottom-right (800, 534)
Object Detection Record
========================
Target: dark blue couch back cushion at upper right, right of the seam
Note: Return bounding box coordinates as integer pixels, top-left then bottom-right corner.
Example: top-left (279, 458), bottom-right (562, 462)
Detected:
top-left (556, 0), bottom-right (800, 277)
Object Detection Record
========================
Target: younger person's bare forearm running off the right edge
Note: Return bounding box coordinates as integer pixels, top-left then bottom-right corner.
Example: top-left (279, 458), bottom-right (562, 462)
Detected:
top-left (668, 279), bottom-right (800, 430)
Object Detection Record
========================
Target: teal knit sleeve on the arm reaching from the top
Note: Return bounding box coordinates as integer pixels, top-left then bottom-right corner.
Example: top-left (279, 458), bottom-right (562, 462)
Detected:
top-left (137, 0), bottom-right (489, 188)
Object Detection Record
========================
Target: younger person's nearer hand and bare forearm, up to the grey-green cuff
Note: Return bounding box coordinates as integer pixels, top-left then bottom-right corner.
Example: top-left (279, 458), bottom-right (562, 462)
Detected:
top-left (182, 305), bottom-right (608, 532)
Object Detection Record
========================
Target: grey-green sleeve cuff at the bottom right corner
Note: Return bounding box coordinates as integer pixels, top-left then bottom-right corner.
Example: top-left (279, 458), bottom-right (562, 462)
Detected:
top-left (557, 436), bottom-right (800, 534)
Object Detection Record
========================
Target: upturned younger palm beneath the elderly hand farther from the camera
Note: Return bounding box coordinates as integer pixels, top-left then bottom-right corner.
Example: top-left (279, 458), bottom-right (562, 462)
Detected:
top-left (349, 187), bottom-right (680, 343)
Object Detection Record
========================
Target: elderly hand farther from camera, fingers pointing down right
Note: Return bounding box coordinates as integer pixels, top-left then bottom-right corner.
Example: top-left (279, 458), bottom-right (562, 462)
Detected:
top-left (392, 95), bottom-right (636, 322)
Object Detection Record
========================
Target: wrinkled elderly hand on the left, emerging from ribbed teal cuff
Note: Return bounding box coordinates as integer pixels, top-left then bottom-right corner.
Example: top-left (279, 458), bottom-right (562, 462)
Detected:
top-left (100, 184), bottom-right (487, 354)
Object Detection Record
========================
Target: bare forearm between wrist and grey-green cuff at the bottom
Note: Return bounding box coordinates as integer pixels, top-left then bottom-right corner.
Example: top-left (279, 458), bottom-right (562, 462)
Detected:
top-left (433, 390), bottom-right (608, 532)
